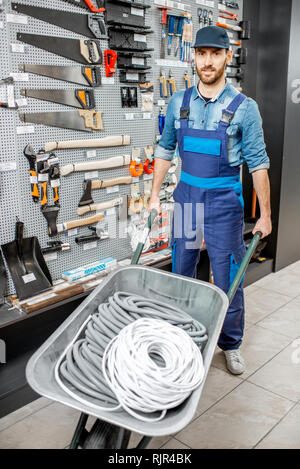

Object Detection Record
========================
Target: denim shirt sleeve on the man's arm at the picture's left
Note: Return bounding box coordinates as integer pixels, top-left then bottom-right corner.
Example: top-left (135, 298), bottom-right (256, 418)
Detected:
top-left (155, 93), bottom-right (177, 161)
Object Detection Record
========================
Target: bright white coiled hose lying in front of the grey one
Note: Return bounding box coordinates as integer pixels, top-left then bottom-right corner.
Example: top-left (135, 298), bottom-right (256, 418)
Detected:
top-left (102, 318), bottom-right (204, 422)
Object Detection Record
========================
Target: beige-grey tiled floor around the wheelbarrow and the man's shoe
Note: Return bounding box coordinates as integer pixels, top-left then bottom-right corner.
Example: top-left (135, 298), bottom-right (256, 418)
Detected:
top-left (0, 262), bottom-right (300, 449)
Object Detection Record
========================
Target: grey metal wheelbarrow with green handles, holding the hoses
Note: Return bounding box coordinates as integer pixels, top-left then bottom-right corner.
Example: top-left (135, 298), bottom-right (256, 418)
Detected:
top-left (26, 211), bottom-right (261, 449)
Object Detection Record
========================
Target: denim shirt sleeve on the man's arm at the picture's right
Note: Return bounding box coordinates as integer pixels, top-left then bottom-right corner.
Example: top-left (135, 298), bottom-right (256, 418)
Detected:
top-left (242, 98), bottom-right (270, 173)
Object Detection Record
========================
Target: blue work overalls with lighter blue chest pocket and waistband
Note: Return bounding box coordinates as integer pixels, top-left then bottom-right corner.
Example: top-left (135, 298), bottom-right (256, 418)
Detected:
top-left (172, 88), bottom-right (246, 350)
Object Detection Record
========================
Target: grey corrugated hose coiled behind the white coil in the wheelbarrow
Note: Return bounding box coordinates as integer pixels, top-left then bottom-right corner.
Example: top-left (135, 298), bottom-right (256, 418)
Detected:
top-left (59, 292), bottom-right (207, 410)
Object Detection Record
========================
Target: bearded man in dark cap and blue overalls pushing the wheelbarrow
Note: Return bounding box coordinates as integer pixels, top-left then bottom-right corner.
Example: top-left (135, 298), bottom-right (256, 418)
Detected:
top-left (150, 26), bottom-right (272, 374)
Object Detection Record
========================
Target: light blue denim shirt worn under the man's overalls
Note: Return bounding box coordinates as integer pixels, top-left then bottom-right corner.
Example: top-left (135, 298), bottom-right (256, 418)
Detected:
top-left (155, 82), bottom-right (270, 173)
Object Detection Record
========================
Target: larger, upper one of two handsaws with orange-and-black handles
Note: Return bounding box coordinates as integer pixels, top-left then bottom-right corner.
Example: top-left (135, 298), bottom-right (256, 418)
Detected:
top-left (19, 64), bottom-right (101, 88)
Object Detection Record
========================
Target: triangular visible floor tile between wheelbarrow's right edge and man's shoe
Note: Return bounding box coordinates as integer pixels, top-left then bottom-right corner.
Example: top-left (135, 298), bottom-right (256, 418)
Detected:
top-left (195, 366), bottom-right (242, 417)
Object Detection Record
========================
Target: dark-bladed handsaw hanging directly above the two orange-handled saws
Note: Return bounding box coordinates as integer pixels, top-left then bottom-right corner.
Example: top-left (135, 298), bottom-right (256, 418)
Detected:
top-left (17, 33), bottom-right (103, 65)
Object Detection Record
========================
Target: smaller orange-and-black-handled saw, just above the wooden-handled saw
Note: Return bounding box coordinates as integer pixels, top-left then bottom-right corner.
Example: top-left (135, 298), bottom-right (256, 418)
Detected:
top-left (20, 89), bottom-right (95, 109)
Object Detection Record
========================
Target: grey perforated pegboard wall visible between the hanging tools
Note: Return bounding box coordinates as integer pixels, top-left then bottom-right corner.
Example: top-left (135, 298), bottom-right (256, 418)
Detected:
top-left (0, 0), bottom-right (243, 294)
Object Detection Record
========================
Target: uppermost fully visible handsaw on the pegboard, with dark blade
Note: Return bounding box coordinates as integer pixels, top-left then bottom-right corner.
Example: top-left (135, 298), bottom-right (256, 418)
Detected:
top-left (11, 2), bottom-right (107, 39)
